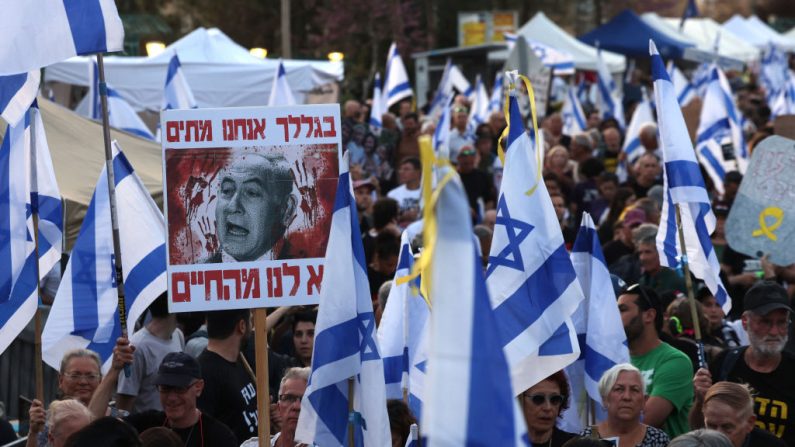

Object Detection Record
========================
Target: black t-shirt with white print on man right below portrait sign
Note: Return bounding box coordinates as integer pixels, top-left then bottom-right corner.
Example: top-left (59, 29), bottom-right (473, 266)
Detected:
top-left (196, 350), bottom-right (258, 445)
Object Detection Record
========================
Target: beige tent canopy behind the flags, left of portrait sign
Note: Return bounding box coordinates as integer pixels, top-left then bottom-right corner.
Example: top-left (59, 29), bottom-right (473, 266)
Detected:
top-left (0, 97), bottom-right (163, 250)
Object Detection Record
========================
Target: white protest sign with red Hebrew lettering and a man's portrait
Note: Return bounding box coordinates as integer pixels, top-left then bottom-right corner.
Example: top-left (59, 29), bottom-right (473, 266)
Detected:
top-left (161, 104), bottom-right (341, 312)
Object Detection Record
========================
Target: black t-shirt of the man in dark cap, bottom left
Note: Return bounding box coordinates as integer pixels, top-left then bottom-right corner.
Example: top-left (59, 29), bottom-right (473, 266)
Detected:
top-left (124, 410), bottom-right (240, 447)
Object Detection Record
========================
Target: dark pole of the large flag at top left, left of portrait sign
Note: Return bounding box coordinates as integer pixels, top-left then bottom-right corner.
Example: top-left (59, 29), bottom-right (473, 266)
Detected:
top-left (97, 53), bottom-right (130, 377)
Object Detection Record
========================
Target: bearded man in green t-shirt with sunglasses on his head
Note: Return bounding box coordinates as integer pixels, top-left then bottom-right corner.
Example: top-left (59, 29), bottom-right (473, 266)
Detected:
top-left (618, 284), bottom-right (693, 438)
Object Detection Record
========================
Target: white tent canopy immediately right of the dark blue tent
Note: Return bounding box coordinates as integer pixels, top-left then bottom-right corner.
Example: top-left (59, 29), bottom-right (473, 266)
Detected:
top-left (656, 13), bottom-right (760, 63)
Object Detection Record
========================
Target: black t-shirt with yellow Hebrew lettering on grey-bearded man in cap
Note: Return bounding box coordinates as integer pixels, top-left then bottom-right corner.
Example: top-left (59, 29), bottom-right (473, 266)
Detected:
top-left (709, 349), bottom-right (795, 446)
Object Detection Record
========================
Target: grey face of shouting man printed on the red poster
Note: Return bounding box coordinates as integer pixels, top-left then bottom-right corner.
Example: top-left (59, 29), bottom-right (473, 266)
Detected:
top-left (215, 153), bottom-right (296, 261)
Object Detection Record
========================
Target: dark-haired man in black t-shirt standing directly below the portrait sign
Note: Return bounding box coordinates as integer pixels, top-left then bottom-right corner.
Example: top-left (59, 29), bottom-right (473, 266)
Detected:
top-left (197, 309), bottom-right (257, 443)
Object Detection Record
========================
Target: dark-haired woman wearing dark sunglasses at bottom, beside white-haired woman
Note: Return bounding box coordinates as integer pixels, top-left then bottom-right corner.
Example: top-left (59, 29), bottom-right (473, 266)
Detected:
top-left (519, 371), bottom-right (577, 447)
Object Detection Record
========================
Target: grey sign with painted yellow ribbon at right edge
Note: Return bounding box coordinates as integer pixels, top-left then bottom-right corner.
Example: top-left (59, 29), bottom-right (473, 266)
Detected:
top-left (726, 135), bottom-right (795, 265)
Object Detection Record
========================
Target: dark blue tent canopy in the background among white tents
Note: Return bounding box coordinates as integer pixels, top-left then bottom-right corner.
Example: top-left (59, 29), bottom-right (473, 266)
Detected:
top-left (579, 9), bottom-right (694, 59)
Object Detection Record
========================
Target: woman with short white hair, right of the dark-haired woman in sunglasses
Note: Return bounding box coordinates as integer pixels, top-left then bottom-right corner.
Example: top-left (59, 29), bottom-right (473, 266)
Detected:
top-left (582, 363), bottom-right (670, 447)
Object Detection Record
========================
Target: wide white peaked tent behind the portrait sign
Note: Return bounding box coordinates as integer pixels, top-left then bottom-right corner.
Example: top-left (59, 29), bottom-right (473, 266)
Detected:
top-left (44, 28), bottom-right (344, 111)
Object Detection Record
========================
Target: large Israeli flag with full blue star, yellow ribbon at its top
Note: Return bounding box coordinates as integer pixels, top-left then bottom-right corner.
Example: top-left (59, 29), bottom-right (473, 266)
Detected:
top-left (486, 79), bottom-right (583, 395)
